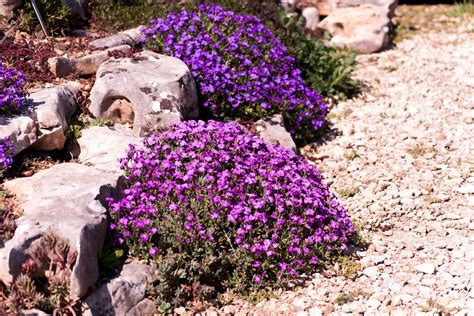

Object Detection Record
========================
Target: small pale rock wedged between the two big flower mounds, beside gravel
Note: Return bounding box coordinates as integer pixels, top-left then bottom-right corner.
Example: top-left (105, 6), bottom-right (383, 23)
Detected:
top-left (255, 114), bottom-right (297, 152)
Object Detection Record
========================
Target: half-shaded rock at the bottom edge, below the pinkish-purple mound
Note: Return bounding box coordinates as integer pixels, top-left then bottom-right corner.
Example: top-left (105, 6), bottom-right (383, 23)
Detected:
top-left (82, 262), bottom-right (156, 316)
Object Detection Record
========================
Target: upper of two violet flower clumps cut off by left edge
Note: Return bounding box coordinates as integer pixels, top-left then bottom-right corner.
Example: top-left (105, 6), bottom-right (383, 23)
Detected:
top-left (0, 59), bottom-right (26, 113)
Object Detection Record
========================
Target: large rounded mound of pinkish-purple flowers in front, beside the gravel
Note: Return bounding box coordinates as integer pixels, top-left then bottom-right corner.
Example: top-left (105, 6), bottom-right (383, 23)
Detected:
top-left (110, 121), bottom-right (354, 286)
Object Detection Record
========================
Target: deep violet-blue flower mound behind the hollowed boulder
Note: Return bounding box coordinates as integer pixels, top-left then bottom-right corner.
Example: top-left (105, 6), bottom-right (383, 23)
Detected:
top-left (142, 5), bottom-right (327, 141)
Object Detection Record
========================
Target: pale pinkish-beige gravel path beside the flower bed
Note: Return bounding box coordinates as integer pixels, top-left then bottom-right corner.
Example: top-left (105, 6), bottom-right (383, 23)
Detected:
top-left (222, 4), bottom-right (474, 315)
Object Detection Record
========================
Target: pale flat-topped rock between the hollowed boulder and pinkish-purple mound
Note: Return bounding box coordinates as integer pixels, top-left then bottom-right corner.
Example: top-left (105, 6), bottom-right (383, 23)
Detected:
top-left (78, 126), bottom-right (142, 173)
